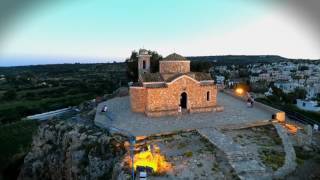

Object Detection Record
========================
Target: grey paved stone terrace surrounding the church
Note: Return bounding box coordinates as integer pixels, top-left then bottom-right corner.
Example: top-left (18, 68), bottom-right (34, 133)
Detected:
top-left (95, 92), bottom-right (272, 136)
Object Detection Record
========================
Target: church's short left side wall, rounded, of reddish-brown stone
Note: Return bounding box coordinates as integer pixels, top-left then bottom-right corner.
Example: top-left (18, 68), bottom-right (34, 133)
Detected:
top-left (130, 87), bottom-right (147, 112)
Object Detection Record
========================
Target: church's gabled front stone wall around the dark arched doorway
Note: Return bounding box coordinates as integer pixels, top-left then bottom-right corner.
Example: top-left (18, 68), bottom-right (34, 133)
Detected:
top-left (146, 76), bottom-right (217, 116)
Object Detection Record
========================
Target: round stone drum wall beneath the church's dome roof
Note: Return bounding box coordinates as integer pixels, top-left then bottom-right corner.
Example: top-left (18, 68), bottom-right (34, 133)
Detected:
top-left (159, 61), bottom-right (190, 74)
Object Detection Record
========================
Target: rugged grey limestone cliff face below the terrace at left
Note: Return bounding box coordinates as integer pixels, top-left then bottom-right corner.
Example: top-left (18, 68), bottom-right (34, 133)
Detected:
top-left (18, 120), bottom-right (126, 180)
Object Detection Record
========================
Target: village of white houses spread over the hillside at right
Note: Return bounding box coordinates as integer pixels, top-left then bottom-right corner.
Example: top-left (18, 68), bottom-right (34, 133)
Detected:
top-left (212, 61), bottom-right (320, 112)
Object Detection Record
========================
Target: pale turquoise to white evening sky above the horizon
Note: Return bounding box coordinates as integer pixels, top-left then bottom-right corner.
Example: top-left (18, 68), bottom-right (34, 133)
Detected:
top-left (0, 0), bottom-right (320, 66)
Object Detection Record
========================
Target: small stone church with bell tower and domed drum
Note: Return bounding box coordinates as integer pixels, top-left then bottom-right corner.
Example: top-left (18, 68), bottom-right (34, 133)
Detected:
top-left (130, 50), bottom-right (217, 117)
